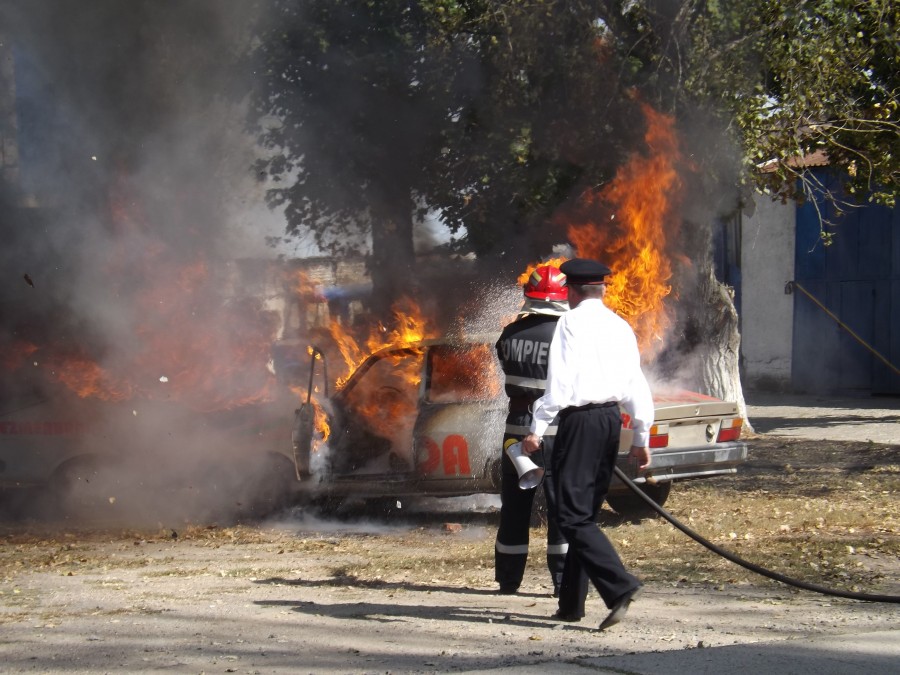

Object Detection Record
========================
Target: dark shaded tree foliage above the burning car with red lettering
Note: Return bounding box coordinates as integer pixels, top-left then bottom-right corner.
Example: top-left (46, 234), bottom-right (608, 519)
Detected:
top-left (250, 0), bottom-right (641, 272)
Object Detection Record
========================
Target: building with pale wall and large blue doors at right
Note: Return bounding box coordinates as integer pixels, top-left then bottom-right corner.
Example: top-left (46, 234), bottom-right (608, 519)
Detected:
top-left (739, 174), bottom-right (900, 396)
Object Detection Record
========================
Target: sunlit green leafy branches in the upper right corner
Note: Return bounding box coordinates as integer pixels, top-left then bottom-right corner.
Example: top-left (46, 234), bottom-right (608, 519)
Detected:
top-left (698, 0), bottom-right (900, 209)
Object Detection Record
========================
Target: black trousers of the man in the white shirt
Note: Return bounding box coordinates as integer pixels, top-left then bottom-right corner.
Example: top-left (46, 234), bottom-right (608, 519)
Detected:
top-left (552, 405), bottom-right (640, 616)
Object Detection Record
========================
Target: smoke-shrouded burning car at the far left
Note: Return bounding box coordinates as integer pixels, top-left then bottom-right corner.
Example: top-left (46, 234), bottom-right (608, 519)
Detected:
top-left (0, 374), bottom-right (296, 520)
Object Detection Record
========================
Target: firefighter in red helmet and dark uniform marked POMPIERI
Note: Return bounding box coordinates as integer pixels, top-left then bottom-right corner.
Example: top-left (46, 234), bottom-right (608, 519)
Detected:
top-left (494, 265), bottom-right (569, 596)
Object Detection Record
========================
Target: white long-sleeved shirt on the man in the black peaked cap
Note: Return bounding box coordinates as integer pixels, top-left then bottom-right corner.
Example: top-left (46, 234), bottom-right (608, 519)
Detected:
top-left (531, 298), bottom-right (654, 447)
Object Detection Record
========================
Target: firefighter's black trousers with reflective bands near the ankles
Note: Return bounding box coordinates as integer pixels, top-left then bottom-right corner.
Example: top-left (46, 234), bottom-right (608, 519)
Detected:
top-left (494, 413), bottom-right (568, 593)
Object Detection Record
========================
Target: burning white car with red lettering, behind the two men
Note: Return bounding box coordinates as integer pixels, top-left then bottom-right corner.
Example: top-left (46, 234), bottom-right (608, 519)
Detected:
top-left (292, 336), bottom-right (747, 512)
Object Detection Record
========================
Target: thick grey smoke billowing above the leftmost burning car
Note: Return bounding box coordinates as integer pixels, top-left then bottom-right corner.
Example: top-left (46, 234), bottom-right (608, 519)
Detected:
top-left (0, 0), bottom-right (291, 522)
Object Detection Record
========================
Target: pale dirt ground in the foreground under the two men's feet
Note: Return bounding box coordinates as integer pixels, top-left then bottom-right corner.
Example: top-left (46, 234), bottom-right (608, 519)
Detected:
top-left (0, 520), bottom-right (897, 673)
